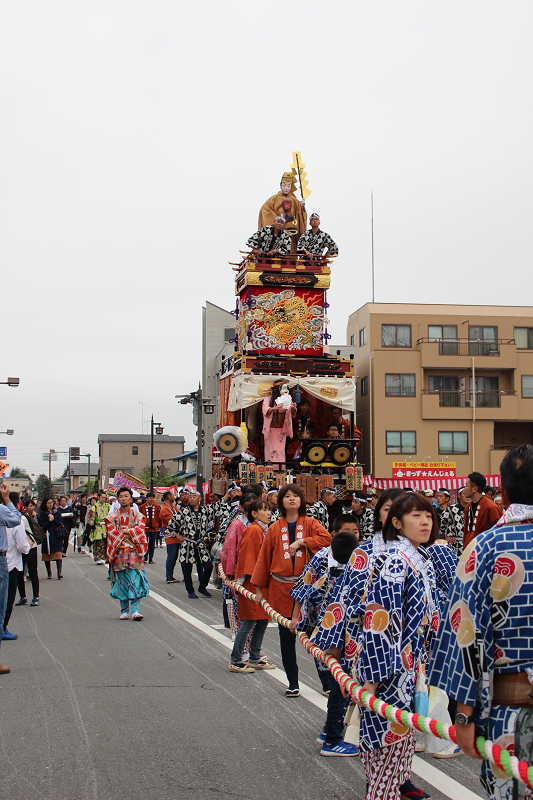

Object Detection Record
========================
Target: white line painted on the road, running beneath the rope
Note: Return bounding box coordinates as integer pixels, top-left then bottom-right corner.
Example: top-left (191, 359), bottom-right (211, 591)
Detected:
top-left (149, 589), bottom-right (480, 800)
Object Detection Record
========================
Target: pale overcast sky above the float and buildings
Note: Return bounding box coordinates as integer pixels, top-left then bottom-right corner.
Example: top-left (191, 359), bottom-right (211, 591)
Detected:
top-left (0, 0), bottom-right (533, 482)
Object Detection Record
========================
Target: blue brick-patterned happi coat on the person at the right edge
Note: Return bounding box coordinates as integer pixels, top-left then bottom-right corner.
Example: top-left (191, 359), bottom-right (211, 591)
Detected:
top-left (429, 504), bottom-right (533, 800)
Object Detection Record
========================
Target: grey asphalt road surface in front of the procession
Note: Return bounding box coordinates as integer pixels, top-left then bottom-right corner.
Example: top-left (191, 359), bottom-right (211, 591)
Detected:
top-left (0, 549), bottom-right (482, 800)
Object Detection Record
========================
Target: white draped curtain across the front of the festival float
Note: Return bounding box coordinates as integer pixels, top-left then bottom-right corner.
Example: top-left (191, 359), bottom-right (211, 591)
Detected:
top-left (228, 373), bottom-right (355, 411)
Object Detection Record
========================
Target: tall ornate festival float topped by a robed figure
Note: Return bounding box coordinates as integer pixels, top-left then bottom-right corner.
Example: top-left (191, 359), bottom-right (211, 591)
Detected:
top-left (211, 152), bottom-right (363, 503)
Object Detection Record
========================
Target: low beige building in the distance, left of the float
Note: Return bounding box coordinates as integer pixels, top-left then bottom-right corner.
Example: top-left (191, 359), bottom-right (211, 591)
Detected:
top-left (97, 433), bottom-right (185, 487)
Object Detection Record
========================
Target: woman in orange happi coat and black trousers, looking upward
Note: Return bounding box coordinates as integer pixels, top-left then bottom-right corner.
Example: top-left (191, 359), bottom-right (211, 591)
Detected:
top-left (251, 483), bottom-right (331, 697)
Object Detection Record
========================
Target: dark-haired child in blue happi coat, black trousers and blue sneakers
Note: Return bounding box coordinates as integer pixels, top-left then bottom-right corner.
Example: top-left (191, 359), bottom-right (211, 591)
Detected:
top-left (290, 514), bottom-right (359, 756)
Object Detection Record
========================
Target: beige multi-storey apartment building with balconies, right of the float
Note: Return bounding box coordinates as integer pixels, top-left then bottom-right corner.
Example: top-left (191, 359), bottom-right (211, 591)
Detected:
top-left (347, 303), bottom-right (533, 478)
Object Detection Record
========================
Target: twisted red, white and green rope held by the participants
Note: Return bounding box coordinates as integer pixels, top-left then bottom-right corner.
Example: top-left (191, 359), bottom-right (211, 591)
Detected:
top-left (218, 565), bottom-right (533, 788)
